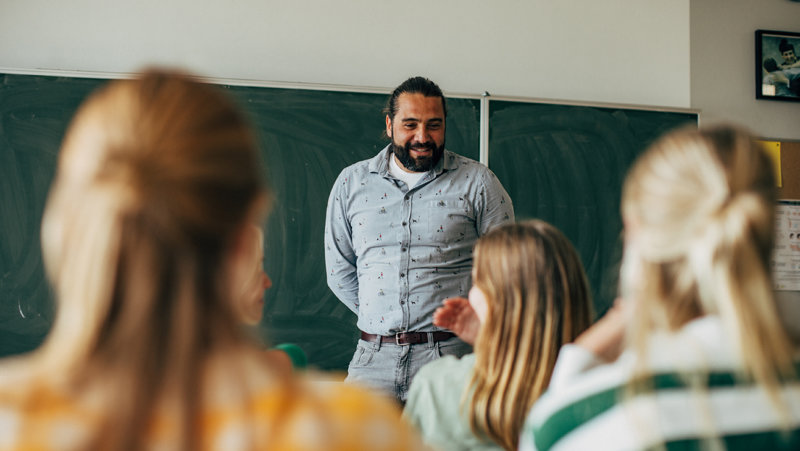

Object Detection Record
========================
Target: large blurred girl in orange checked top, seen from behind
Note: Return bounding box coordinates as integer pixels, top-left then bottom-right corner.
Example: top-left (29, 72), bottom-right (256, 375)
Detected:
top-left (0, 71), bottom-right (418, 450)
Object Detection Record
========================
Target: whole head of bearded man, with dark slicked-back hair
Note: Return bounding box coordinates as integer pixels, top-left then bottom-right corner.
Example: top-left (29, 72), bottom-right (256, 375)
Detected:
top-left (384, 77), bottom-right (447, 172)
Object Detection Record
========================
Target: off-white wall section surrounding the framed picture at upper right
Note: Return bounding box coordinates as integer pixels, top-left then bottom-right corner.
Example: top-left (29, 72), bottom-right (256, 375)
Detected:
top-left (691, 0), bottom-right (800, 140)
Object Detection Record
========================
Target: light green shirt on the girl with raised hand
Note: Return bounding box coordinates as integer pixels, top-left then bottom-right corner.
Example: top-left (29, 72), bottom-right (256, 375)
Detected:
top-left (403, 354), bottom-right (502, 451)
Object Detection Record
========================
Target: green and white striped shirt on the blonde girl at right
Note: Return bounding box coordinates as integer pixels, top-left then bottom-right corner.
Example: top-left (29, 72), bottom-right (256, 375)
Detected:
top-left (520, 317), bottom-right (800, 450)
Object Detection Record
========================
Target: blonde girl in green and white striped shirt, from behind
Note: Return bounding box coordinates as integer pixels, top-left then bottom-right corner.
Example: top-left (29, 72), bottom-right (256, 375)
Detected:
top-left (520, 126), bottom-right (800, 450)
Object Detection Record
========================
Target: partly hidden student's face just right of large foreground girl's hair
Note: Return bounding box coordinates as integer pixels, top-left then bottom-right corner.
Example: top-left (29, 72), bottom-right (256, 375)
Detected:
top-left (233, 225), bottom-right (272, 326)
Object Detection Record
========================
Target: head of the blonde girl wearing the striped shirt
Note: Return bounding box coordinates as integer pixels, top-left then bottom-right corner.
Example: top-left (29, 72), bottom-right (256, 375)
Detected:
top-left (622, 127), bottom-right (775, 329)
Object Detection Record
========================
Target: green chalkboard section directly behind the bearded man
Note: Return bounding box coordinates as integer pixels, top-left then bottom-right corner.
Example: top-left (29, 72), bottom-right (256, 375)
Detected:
top-left (241, 87), bottom-right (480, 370)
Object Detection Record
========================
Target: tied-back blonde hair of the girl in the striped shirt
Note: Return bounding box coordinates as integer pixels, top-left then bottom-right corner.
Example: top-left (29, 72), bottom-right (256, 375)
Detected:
top-left (621, 126), bottom-right (793, 410)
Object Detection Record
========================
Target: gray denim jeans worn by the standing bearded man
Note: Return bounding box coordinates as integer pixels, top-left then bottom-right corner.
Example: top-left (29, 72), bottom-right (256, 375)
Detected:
top-left (345, 337), bottom-right (472, 404)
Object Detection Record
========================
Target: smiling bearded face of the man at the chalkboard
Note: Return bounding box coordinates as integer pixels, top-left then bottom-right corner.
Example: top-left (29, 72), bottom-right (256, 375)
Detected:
top-left (386, 92), bottom-right (445, 172)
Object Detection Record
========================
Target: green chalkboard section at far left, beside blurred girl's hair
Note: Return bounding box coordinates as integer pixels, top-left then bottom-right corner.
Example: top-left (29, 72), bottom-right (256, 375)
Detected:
top-left (0, 76), bottom-right (100, 355)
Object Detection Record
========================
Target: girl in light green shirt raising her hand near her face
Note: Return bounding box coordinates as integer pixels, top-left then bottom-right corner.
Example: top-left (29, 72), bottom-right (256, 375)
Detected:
top-left (403, 220), bottom-right (592, 451)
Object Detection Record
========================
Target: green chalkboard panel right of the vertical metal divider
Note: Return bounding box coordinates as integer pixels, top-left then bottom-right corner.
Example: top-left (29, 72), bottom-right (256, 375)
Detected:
top-left (489, 100), bottom-right (697, 314)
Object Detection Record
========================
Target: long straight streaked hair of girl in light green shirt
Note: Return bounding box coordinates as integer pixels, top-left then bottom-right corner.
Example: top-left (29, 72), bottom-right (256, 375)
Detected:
top-left (463, 220), bottom-right (592, 449)
